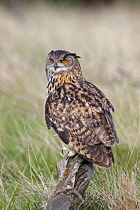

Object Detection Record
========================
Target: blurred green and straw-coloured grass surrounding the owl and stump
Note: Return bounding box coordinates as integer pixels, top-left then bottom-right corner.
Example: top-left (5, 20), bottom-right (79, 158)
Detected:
top-left (0, 2), bottom-right (140, 210)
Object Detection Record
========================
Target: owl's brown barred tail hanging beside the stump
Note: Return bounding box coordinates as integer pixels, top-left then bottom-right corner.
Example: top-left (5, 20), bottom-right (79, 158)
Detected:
top-left (80, 143), bottom-right (114, 168)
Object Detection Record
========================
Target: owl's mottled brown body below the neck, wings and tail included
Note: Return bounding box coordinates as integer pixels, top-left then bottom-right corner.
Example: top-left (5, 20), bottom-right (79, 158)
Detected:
top-left (45, 83), bottom-right (118, 167)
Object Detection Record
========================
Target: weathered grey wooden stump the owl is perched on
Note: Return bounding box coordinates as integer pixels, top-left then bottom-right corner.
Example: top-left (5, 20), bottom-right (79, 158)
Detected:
top-left (40, 155), bottom-right (93, 210)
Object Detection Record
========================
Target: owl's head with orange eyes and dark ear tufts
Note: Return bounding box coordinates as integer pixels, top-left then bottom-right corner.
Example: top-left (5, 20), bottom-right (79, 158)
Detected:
top-left (45, 50), bottom-right (82, 80)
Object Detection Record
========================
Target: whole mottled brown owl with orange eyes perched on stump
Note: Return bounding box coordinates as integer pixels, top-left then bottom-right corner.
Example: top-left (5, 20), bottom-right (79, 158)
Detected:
top-left (45, 50), bottom-right (118, 168)
